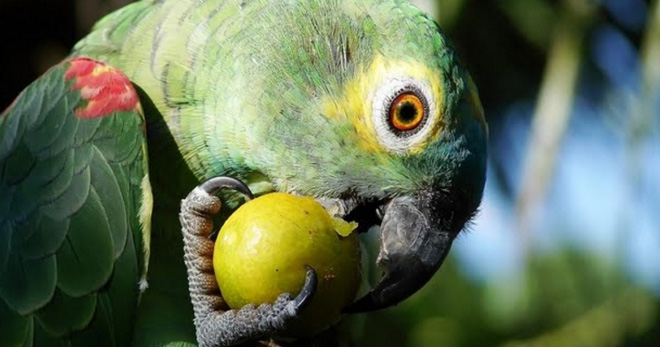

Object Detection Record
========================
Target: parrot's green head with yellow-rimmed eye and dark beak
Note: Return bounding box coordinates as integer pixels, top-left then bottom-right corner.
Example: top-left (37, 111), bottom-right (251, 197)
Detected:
top-left (209, 1), bottom-right (488, 312)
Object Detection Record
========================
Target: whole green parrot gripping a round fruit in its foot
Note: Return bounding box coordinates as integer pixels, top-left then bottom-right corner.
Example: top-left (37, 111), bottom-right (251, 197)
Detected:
top-left (0, 0), bottom-right (488, 346)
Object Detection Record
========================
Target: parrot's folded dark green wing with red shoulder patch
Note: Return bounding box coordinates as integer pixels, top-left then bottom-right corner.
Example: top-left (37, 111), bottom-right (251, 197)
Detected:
top-left (0, 58), bottom-right (151, 346)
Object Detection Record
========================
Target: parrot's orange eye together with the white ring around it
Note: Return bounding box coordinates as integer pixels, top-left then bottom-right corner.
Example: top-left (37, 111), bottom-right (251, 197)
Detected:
top-left (372, 78), bottom-right (435, 154)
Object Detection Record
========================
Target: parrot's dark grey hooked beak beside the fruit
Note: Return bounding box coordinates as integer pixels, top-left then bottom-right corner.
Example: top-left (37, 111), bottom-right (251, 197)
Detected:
top-left (344, 193), bottom-right (456, 313)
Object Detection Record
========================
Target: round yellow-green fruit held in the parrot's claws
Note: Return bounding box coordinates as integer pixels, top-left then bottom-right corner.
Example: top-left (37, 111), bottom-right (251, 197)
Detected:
top-left (213, 193), bottom-right (360, 336)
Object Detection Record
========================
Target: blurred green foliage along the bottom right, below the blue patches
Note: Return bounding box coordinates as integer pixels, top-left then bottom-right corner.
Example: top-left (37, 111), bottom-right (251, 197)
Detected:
top-left (358, 251), bottom-right (660, 347)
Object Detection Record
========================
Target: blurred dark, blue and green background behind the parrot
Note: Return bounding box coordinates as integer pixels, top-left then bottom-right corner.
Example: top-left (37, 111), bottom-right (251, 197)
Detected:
top-left (0, 0), bottom-right (660, 347)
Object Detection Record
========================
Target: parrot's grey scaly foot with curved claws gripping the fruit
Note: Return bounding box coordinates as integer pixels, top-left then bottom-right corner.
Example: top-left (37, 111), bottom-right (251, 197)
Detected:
top-left (179, 177), bottom-right (317, 346)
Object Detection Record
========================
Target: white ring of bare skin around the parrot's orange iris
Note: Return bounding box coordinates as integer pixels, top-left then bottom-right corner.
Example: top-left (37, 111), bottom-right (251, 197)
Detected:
top-left (371, 77), bottom-right (437, 154)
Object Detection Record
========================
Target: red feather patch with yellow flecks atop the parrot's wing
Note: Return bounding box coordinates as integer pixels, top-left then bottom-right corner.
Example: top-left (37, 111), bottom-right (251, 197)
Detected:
top-left (64, 58), bottom-right (142, 118)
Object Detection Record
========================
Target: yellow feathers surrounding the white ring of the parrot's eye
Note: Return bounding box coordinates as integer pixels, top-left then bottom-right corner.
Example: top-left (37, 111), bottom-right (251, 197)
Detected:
top-left (321, 54), bottom-right (444, 154)
